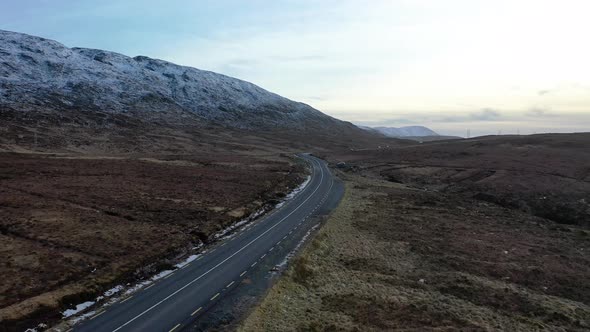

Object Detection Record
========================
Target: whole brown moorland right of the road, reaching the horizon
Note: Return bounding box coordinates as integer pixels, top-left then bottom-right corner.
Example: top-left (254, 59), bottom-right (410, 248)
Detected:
top-left (239, 134), bottom-right (590, 331)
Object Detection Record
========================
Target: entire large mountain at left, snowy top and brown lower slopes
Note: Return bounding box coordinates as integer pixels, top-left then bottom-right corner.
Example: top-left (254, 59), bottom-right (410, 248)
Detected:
top-left (0, 30), bottom-right (394, 153)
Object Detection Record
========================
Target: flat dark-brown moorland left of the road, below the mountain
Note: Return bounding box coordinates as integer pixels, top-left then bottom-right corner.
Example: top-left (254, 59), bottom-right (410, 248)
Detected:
top-left (0, 153), bottom-right (303, 331)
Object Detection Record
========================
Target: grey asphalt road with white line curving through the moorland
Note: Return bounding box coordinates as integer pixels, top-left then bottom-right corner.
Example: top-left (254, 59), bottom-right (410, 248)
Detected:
top-left (73, 155), bottom-right (334, 332)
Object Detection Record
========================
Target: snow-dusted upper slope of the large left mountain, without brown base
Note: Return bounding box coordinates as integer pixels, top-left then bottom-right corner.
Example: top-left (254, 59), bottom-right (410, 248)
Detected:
top-left (0, 30), bottom-right (358, 132)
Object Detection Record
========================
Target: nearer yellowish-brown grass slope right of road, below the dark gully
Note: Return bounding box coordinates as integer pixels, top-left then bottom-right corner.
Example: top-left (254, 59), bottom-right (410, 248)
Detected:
top-left (240, 175), bottom-right (590, 331)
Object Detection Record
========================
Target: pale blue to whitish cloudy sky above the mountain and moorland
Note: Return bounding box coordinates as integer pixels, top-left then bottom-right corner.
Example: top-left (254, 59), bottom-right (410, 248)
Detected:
top-left (0, 0), bottom-right (590, 136)
